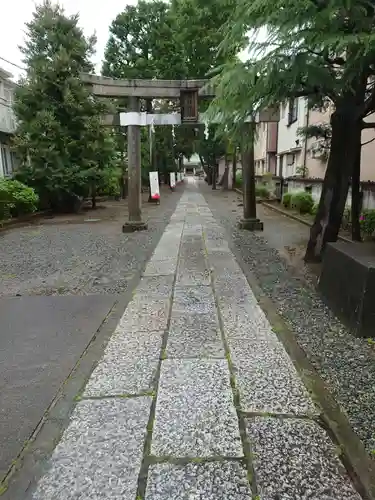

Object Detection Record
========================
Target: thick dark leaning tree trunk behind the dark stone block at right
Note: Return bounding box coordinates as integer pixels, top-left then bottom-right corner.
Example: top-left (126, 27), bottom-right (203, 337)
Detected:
top-left (305, 110), bottom-right (359, 262)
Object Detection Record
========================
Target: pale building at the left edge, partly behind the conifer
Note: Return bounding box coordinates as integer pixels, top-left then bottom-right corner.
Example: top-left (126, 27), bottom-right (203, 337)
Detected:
top-left (0, 68), bottom-right (17, 177)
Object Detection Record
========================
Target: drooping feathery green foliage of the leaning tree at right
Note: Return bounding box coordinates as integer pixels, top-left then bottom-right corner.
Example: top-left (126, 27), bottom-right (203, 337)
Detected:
top-left (211, 0), bottom-right (375, 131)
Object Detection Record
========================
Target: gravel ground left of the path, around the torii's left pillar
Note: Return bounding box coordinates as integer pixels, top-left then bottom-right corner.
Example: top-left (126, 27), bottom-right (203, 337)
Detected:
top-left (0, 187), bottom-right (183, 297)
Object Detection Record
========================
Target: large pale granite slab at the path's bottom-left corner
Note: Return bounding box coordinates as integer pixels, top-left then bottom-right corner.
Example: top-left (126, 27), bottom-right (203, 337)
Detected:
top-left (32, 397), bottom-right (151, 500)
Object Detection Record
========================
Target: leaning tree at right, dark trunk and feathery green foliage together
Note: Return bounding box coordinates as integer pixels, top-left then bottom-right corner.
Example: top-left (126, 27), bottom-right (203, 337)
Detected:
top-left (211, 0), bottom-right (375, 261)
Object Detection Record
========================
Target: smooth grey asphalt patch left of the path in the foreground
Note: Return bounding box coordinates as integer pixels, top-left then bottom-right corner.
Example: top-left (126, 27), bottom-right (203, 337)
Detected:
top-left (0, 295), bottom-right (115, 479)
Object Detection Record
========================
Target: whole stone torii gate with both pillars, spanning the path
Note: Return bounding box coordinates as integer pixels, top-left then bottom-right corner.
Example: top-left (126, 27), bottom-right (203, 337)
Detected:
top-left (81, 74), bottom-right (279, 232)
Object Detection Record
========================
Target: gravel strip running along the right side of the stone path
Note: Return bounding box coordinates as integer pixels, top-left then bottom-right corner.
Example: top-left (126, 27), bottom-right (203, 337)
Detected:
top-left (201, 183), bottom-right (375, 455)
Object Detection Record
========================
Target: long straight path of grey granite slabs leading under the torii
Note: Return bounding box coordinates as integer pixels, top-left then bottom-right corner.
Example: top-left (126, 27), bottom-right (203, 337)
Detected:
top-left (31, 182), bottom-right (360, 500)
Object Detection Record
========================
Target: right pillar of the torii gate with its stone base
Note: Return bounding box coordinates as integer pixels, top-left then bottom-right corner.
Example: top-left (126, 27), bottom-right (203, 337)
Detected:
top-left (238, 121), bottom-right (263, 231)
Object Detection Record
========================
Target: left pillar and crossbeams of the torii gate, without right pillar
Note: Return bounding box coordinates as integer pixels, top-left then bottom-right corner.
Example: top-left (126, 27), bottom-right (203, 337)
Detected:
top-left (82, 74), bottom-right (214, 232)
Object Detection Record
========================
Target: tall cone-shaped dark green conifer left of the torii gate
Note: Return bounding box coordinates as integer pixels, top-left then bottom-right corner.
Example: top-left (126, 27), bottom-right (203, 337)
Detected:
top-left (14, 0), bottom-right (114, 210)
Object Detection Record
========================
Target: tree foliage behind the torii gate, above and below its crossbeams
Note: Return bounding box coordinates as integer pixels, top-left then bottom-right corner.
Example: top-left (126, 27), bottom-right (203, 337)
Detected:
top-left (103, 0), bottom-right (238, 177)
